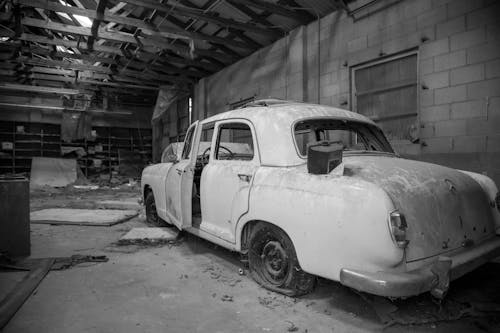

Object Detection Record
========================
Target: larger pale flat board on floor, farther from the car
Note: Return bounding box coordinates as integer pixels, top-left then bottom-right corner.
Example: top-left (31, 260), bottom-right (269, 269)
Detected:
top-left (30, 208), bottom-right (137, 226)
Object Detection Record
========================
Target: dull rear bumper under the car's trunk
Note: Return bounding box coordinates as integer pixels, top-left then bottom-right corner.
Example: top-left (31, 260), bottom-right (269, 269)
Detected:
top-left (340, 237), bottom-right (500, 298)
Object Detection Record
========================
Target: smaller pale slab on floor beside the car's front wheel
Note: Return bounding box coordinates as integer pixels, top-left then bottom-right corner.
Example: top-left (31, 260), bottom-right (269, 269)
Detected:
top-left (118, 228), bottom-right (179, 245)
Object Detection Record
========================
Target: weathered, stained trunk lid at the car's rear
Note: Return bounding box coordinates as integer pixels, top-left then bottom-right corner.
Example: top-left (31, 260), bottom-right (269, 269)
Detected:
top-left (343, 154), bottom-right (495, 262)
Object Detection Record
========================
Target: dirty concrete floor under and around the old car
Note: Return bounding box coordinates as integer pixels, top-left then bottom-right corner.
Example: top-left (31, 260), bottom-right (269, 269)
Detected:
top-left (0, 185), bottom-right (500, 333)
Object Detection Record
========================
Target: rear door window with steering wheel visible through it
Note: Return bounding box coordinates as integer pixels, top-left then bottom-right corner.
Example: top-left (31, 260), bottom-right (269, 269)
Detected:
top-left (215, 123), bottom-right (254, 161)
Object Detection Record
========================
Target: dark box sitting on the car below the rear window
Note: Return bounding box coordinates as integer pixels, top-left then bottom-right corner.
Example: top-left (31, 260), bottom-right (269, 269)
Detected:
top-left (307, 142), bottom-right (343, 175)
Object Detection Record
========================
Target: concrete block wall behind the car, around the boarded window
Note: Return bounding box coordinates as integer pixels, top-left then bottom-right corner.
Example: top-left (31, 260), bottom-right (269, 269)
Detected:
top-left (195, 0), bottom-right (500, 185)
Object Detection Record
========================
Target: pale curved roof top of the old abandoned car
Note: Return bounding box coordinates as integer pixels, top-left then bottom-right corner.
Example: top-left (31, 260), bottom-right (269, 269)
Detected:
top-left (202, 99), bottom-right (375, 126)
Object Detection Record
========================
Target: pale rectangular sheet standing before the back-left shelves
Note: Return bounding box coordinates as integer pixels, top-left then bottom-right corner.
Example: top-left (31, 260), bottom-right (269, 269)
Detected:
top-left (30, 157), bottom-right (77, 188)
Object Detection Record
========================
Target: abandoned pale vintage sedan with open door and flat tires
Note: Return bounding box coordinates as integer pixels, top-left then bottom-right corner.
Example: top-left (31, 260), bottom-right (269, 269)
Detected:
top-left (142, 100), bottom-right (500, 298)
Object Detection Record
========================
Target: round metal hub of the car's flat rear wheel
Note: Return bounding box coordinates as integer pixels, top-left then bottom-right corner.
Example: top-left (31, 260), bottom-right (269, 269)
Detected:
top-left (260, 241), bottom-right (288, 284)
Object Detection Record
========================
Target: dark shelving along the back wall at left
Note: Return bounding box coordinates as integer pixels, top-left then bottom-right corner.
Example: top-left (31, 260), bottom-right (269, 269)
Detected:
top-left (0, 121), bottom-right (152, 176)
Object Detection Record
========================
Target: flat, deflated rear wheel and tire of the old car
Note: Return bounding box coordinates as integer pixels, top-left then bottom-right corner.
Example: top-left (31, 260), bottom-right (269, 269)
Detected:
top-left (248, 223), bottom-right (316, 296)
